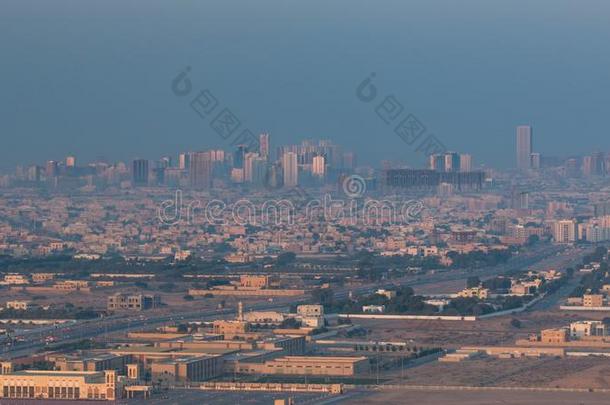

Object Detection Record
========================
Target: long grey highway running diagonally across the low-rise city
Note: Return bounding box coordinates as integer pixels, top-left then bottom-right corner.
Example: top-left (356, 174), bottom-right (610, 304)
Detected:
top-left (2, 241), bottom-right (586, 359)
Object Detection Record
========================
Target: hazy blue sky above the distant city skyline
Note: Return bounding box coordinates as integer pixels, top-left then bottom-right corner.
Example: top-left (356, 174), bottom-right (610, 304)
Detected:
top-left (0, 0), bottom-right (610, 168)
